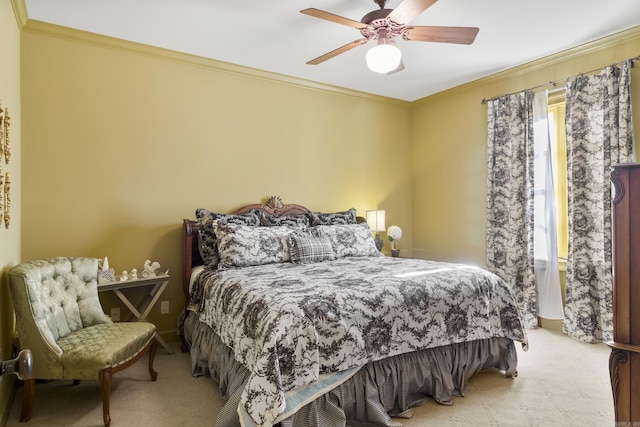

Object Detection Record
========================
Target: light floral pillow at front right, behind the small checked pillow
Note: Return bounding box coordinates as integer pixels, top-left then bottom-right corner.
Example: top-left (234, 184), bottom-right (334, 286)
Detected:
top-left (312, 222), bottom-right (383, 258)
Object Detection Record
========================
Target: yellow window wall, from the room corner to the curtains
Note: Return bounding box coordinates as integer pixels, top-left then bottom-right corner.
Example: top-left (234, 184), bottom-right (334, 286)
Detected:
top-left (410, 27), bottom-right (640, 266)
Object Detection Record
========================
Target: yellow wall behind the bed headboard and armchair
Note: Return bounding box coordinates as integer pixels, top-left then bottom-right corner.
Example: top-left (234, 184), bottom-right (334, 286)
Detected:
top-left (22, 21), bottom-right (412, 339)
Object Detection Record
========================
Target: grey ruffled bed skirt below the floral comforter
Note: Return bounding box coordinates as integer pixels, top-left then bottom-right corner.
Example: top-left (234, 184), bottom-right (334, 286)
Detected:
top-left (184, 313), bottom-right (518, 427)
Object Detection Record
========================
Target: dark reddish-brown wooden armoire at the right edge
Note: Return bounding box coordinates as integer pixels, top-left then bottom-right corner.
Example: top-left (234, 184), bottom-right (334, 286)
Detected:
top-left (608, 163), bottom-right (640, 425)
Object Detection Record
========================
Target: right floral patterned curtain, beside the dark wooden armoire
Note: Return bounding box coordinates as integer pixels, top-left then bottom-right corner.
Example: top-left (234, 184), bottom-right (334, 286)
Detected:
top-left (563, 62), bottom-right (633, 342)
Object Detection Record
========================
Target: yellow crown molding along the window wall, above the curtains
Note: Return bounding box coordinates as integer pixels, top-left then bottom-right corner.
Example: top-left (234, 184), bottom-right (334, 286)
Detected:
top-left (413, 26), bottom-right (640, 105)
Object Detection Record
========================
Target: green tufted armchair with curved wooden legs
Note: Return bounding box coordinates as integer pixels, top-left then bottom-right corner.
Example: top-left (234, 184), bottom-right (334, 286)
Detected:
top-left (9, 258), bottom-right (158, 427)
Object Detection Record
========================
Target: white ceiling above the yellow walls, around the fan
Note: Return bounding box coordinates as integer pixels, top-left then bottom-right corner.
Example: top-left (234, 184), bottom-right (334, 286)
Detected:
top-left (25, 0), bottom-right (640, 101)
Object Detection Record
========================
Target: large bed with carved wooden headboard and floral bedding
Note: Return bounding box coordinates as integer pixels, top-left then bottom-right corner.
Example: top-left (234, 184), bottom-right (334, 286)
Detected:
top-left (178, 197), bottom-right (527, 427)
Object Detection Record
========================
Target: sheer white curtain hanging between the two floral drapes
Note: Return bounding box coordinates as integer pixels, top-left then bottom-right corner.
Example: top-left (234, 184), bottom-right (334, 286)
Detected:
top-left (533, 91), bottom-right (564, 319)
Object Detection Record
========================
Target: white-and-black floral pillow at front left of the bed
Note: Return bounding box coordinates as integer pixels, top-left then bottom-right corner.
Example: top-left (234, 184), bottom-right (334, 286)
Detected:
top-left (213, 220), bottom-right (304, 270)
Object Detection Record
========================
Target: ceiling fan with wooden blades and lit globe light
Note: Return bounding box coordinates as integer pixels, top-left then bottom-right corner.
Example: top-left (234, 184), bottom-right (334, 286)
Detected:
top-left (300, 0), bottom-right (479, 74)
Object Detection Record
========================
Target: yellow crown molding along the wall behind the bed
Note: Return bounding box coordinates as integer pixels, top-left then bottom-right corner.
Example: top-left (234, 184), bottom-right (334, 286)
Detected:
top-left (21, 18), bottom-right (409, 106)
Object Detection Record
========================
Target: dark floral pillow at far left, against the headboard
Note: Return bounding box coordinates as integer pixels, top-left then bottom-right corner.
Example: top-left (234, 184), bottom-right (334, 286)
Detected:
top-left (196, 208), bottom-right (260, 267)
